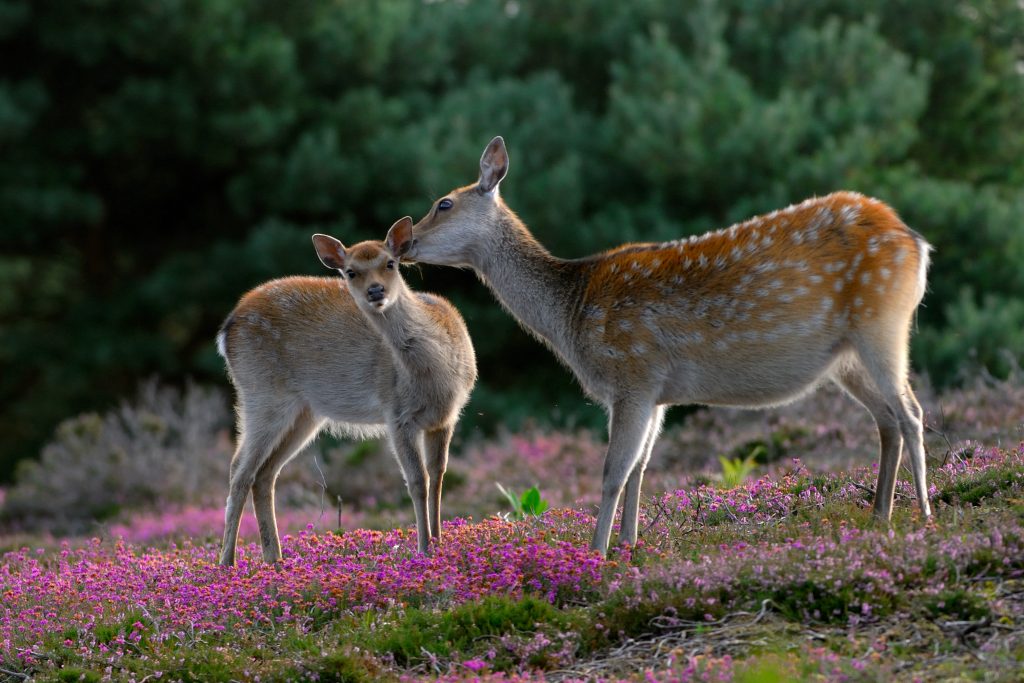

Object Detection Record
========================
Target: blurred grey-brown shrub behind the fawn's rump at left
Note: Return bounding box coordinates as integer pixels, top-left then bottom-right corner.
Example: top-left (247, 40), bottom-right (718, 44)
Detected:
top-left (0, 380), bottom-right (231, 530)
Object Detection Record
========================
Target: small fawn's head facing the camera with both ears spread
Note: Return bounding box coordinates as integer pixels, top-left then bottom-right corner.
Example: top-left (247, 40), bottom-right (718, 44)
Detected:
top-left (313, 216), bottom-right (413, 313)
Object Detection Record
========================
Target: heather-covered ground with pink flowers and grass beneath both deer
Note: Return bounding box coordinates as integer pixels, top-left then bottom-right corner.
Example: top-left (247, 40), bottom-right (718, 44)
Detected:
top-left (0, 376), bottom-right (1024, 682)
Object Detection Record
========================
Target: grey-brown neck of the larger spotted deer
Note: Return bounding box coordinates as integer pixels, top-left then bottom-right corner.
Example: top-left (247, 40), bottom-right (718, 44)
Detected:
top-left (473, 211), bottom-right (584, 365)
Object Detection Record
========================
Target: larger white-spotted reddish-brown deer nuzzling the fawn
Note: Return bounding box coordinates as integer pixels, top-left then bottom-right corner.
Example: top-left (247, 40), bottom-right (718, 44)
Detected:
top-left (409, 137), bottom-right (930, 553)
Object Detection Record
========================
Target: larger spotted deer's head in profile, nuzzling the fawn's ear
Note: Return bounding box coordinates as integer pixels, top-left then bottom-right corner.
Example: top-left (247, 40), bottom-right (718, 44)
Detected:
top-left (410, 135), bottom-right (509, 266)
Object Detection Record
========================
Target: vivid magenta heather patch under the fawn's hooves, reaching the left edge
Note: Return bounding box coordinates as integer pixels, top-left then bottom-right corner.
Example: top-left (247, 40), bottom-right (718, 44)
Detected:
top-left (0, 514), bottom-right (602, 661)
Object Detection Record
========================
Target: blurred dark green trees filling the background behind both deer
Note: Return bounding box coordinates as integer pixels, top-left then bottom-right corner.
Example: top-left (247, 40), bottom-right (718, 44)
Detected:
top-left (0, 0), bottom-right (1024, 482)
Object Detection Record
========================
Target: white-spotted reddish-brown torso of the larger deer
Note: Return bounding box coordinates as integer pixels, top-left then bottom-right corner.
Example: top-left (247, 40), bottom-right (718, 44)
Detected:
top-left (578, 193), bottom-right (928, 404)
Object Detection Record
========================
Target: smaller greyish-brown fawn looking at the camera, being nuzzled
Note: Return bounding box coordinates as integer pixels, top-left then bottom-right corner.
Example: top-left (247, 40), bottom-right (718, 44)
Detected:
top-left (217, 217), bottom-right (476, 565)
